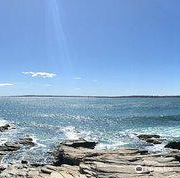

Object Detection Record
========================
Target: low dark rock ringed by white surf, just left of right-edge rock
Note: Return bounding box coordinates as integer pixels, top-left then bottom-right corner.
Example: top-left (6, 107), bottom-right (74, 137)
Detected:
top-left (138, 134), bottom-right (163, 144)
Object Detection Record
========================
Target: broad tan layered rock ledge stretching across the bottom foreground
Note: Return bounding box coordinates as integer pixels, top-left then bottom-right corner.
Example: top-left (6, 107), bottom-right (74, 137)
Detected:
top-left (0, 139), bottom-right (180, 178)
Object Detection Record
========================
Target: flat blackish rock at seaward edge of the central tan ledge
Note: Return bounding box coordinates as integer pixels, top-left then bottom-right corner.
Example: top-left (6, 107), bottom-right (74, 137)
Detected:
top-left (61, 139), bottom-right (97, 149)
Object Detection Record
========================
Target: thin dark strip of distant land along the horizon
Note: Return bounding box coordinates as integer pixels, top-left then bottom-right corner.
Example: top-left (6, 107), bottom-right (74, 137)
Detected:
top-left (0, 95), bottom-right (180, 99)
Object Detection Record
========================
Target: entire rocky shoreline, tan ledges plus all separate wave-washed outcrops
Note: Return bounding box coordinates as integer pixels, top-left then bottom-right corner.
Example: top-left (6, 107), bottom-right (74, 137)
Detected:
top-left (0, 125), bottom-right (180, 178)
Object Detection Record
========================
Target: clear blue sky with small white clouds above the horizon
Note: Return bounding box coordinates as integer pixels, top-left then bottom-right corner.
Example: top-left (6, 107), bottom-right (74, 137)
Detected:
top-left (0, 0), bottom-right (180, 95)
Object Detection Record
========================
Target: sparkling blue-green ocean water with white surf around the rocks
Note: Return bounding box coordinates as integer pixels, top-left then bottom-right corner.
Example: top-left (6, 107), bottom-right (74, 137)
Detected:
top-left (0, 97), bottom-right (180, 163)
